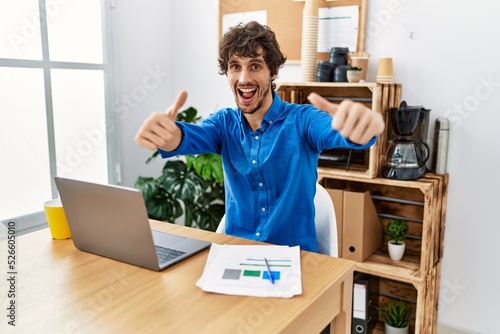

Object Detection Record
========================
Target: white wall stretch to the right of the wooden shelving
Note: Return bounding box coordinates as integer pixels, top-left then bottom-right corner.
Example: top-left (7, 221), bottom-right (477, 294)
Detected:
top-left (367, 0), bottom-right (500, 333)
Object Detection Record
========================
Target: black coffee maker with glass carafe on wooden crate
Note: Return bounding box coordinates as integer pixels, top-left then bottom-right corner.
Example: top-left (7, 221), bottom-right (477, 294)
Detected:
top-left (382, 101), bottom-right (430, 180)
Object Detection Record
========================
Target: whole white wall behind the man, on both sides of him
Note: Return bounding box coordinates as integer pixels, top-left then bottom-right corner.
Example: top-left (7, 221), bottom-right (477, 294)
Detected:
top-left (113, 0), bottom-right (500, 333)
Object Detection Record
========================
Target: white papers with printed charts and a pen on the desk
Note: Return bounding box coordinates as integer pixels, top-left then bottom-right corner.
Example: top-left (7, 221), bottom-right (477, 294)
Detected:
top-left (197, 244), bottom-right (302, 298)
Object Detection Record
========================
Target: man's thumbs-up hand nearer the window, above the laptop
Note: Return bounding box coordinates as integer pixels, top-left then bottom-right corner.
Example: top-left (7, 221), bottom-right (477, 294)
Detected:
top-left (135, 90), bottom-right (187, 151)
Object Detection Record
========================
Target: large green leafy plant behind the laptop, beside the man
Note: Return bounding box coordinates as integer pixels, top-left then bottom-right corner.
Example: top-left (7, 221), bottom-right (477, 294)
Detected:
top-left (135, 107), bottom-right (225, 231)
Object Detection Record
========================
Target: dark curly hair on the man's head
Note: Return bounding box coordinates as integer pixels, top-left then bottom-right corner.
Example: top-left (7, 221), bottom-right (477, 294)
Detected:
top-left (219, 21), bottom-right (286, 88)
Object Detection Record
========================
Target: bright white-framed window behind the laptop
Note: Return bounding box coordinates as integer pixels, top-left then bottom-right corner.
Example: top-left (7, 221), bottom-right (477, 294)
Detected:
top-left (0, 0), bottom-right (112, 234)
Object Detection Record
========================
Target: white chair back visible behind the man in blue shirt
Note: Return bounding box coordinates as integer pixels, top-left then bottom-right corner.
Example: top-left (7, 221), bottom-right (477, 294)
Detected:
top-left (216, 183), bottom-right (339, 257)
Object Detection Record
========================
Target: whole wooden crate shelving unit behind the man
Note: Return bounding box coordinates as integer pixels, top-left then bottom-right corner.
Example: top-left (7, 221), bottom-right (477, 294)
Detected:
top-left (277, 82), bottom-right (448, 334)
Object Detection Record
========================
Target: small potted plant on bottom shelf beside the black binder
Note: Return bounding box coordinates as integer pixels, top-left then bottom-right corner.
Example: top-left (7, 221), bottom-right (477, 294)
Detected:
top-left (378, 301), bottom-right (410, 334)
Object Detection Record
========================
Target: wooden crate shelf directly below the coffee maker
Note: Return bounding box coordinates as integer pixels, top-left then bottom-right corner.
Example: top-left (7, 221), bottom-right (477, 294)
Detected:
top-left (318, 172), bottom-right (448, 285)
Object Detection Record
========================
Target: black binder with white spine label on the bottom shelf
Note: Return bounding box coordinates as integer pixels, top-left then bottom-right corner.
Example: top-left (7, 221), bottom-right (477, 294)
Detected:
top-left (351, 272), bottom-right (378, 334)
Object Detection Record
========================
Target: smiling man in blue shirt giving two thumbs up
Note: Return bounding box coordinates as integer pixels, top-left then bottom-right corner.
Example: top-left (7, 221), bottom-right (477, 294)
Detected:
top-left (135, 22), bottom-right (384, 251)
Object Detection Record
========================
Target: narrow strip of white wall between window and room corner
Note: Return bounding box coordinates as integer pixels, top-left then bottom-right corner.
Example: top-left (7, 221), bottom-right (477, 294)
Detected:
top-left (111, 0), bottom-right (175, 186)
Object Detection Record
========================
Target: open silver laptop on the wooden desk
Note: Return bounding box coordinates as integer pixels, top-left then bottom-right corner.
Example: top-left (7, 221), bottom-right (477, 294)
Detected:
top-left (55, 176), bottom-right (211, 271)
